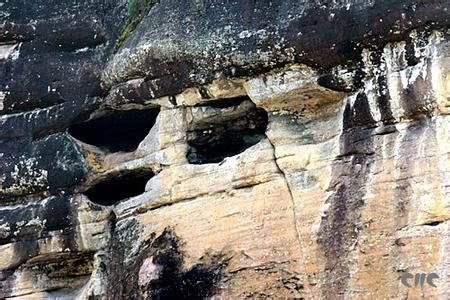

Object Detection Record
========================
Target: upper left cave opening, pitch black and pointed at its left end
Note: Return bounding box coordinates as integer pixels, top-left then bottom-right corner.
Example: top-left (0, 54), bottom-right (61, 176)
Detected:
top-left (68, 108), bottom-right (160, 152)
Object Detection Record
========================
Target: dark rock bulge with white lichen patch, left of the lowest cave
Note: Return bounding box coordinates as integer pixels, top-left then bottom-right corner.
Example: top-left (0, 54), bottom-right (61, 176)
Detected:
top-left (0, 133), bottom-right (89, 203)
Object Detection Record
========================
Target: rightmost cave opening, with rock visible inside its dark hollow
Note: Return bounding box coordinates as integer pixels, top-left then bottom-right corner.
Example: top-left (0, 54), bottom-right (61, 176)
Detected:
top-left (187, 97), bottom-right (268, 164)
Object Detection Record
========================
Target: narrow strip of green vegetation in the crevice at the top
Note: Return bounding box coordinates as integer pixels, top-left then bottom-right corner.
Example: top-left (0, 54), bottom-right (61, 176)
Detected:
top-left (114, 0), bottom-right (159, 52)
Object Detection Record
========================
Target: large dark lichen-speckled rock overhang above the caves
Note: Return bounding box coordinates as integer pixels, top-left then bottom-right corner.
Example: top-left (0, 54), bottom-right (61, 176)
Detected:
top-left (102, 0), bottom-right (449, 102)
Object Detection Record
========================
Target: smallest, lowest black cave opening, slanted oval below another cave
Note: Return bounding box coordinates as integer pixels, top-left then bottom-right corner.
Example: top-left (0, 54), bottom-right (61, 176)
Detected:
top-left (83, 170), bottom-right (154, 206)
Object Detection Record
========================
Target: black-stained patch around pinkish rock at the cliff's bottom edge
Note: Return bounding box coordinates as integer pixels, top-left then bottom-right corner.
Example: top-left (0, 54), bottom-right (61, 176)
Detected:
top-left (110, 225), bottom-right (229, 299)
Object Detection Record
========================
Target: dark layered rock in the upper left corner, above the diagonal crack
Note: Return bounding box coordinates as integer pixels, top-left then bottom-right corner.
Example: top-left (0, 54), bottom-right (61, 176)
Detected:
top-left (0, 0), bottom-right (122, 114)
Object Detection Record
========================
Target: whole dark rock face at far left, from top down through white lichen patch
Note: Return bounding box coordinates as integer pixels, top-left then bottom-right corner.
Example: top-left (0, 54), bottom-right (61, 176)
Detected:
top-left (0, 0), bottom-right (124, 202)
